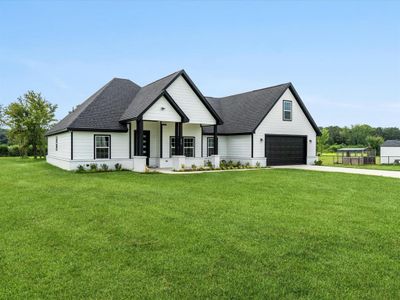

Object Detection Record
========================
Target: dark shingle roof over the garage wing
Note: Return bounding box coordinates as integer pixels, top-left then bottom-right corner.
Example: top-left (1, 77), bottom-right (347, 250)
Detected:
top-left (204, 83), bottom-right (319, 134)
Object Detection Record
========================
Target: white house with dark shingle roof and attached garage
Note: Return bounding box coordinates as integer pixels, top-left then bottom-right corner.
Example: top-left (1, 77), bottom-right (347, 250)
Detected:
top-left (47, 70), bottom-right (320, 171)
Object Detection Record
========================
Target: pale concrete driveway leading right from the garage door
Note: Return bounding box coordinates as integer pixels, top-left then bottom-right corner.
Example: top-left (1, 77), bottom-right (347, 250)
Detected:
top-left (272, 165), bottom-right (400, 179)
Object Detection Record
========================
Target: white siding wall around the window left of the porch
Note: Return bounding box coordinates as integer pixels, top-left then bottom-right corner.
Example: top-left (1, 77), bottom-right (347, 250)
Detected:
top-left (74, 131), bottom-right (129, 161)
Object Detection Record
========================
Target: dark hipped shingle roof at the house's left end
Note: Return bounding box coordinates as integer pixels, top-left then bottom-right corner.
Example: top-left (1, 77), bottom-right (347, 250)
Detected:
top-left (47, 78), bottom-right (140, 135)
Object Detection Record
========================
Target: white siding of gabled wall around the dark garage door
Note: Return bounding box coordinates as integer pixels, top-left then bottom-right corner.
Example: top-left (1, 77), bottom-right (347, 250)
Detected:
top-left (254, 89), bottom-right (317, 164)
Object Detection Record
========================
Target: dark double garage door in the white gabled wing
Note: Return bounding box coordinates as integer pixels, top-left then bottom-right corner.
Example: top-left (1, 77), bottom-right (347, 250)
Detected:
top-left (265, 134), bottom-right (307, 166)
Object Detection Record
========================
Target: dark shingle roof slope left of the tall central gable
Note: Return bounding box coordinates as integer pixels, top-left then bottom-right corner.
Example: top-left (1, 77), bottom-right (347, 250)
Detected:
top-left (120, 70), bottom-right (182, 121)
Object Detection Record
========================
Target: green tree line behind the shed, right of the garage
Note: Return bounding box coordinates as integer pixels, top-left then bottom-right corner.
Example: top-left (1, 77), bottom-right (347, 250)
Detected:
top-left (317, 124), bottom-right (400, 153)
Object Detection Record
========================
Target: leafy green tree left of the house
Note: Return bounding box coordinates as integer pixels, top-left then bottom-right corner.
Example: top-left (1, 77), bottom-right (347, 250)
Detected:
top-left (1, 91), bottom-right (57, 158)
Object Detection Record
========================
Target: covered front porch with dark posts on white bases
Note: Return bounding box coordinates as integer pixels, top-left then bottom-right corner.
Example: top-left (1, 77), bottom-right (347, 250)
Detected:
top-left (128, 120), bottom-right (219, 172)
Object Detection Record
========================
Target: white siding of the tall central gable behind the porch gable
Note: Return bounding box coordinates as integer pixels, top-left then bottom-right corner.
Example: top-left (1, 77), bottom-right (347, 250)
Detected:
top-left (167, 76), bottom-right (216, 125)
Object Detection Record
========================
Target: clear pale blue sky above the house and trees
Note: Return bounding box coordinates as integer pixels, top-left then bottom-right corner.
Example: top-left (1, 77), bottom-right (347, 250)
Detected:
top-left (0, 1), bottom-right (400, 127)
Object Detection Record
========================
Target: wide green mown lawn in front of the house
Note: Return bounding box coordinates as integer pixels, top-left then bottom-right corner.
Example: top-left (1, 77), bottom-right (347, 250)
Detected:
top-left (0, 158), bottom-right (400, 299)
